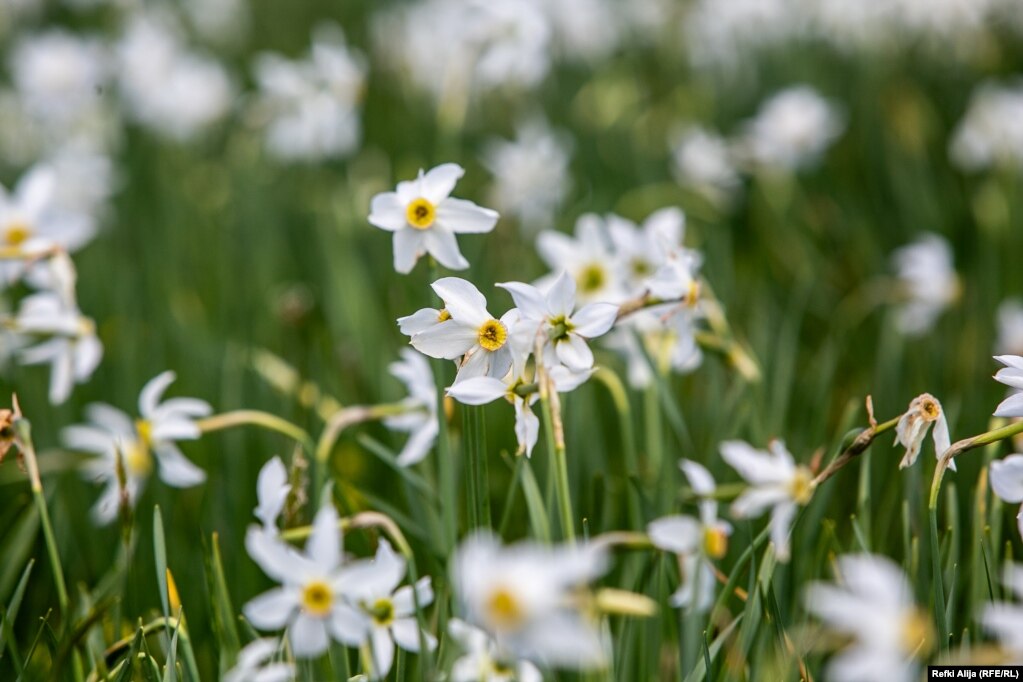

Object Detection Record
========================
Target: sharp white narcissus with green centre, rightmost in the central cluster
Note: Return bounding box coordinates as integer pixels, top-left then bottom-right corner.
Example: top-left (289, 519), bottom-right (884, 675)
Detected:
top-left (497, 272), bottom-right (618, 372)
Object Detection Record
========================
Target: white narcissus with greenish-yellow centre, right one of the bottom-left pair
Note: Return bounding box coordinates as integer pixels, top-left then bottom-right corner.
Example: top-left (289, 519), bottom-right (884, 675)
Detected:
top-left (331, 540), bottom-right (437, 680)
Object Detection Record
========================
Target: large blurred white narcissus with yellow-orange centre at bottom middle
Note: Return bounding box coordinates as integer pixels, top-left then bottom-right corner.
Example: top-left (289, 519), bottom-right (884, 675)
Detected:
top-left (452, 533), bottom-right (608, 669)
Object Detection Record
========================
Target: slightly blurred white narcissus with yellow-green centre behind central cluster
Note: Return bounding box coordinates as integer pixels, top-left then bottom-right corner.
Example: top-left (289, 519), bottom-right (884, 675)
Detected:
top-left (536, 214), bottom-right (626, 303)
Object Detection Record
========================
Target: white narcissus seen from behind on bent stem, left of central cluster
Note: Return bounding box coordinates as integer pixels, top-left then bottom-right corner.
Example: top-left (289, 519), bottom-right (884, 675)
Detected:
top-left (384, 348), bottom-right (440, 466)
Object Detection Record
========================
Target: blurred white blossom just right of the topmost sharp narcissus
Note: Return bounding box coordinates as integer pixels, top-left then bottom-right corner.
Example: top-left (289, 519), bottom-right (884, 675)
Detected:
top-left (483, 121), bottom-right (571, 232)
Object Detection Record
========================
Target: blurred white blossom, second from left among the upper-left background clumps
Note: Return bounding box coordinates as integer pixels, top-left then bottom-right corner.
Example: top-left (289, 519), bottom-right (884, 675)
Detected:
top-left (118, 11), bottom-right (234, 141)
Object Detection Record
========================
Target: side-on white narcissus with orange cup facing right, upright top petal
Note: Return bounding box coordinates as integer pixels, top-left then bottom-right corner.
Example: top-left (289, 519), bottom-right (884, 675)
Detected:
top-left (647, 459), bottom-right (731, 612)
